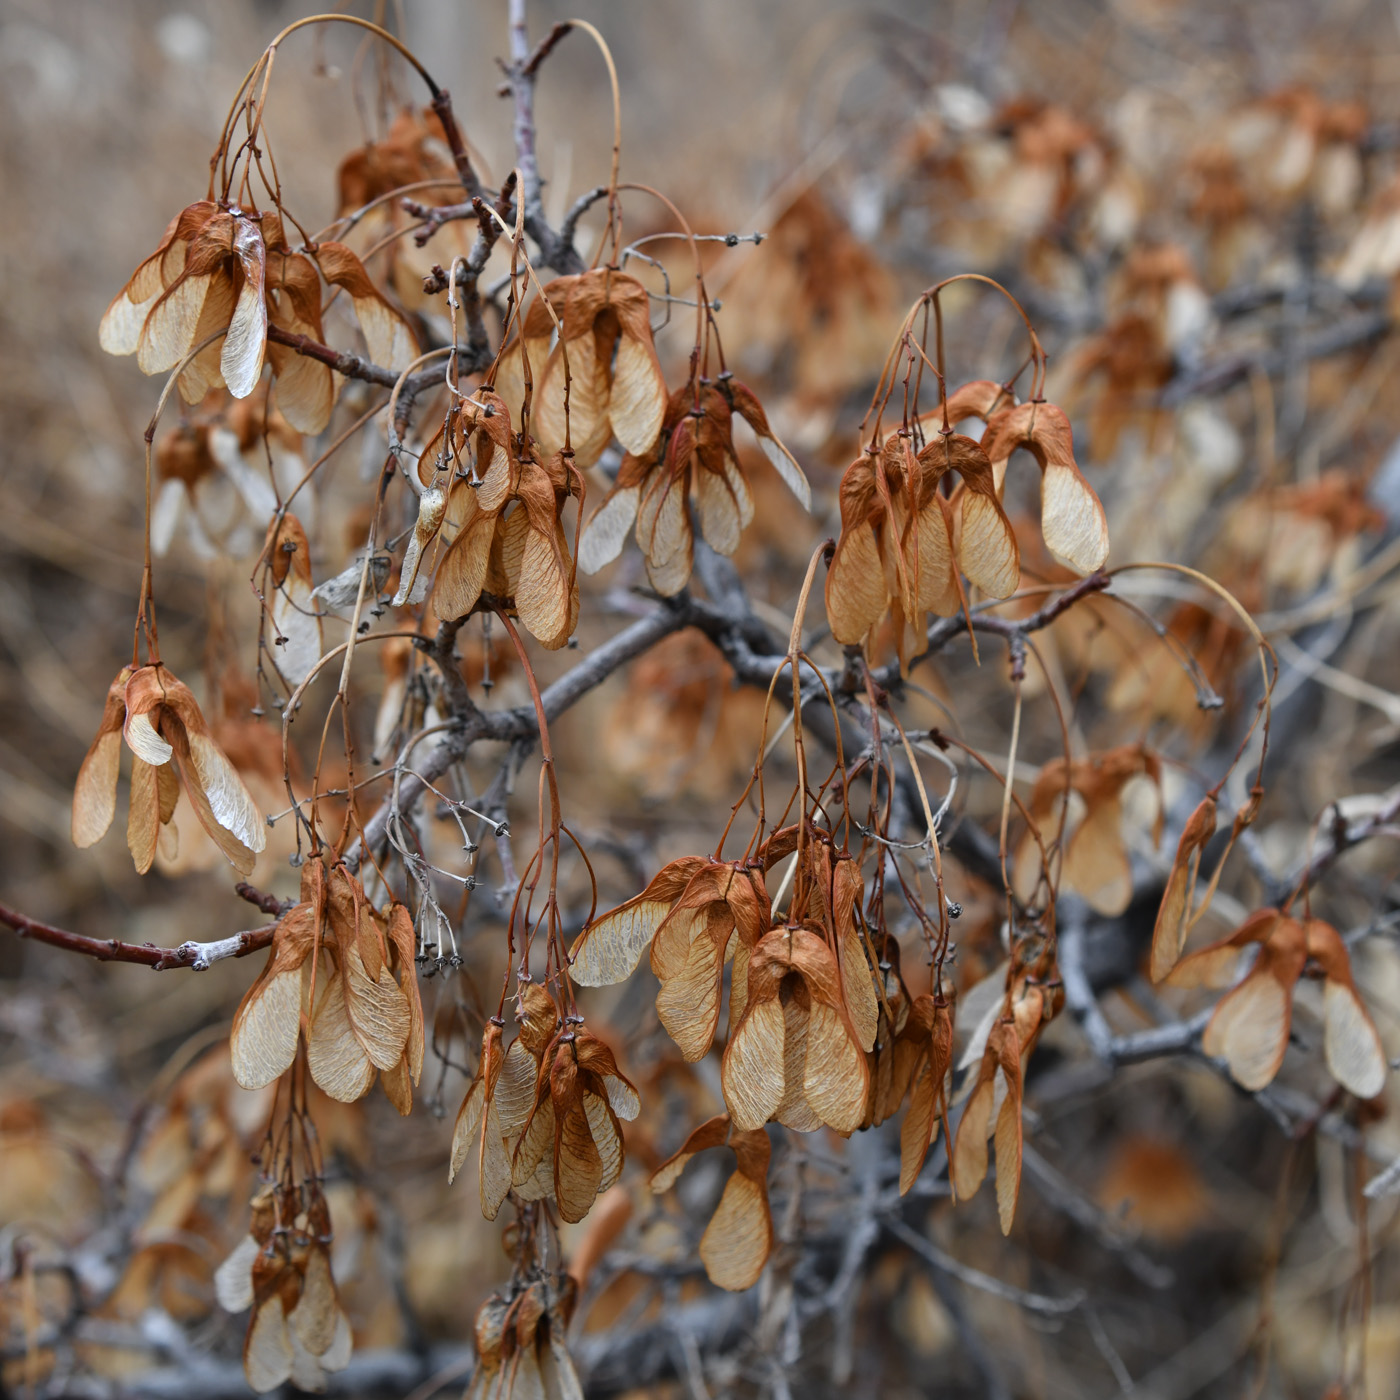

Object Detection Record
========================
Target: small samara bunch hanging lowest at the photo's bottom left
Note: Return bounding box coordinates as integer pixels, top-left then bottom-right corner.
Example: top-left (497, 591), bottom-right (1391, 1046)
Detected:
top-left (214, 1183), bottom-right (353, 1394)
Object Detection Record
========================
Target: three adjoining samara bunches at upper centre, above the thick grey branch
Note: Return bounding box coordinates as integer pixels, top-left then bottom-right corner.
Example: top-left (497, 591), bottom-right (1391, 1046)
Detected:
top-left (393, 267), bottom-right (811, 648)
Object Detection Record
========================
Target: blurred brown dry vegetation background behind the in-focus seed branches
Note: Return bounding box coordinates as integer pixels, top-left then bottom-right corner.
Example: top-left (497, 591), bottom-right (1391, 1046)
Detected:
top-left (0, 0), bottom-right (1400, 1400)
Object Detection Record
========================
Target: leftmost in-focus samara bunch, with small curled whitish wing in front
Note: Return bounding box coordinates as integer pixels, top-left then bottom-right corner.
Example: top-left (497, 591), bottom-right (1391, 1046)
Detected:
top-left (73, 661), bottom-right (267, 875)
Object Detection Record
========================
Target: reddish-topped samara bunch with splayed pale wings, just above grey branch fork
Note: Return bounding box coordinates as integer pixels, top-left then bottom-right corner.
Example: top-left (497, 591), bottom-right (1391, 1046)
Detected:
top-left (578, 372), bottom-right (812, 596)
